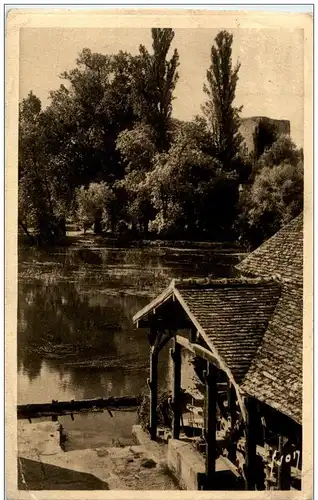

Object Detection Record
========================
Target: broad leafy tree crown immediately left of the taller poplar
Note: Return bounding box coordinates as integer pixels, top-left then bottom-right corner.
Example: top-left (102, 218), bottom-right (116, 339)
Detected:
top-left (45, 49), bottom-right (136, 190)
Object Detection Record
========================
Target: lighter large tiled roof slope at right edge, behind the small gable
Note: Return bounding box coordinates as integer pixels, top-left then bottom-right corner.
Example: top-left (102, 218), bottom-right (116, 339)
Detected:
top-left (237, 214), bottom-right (303, 423)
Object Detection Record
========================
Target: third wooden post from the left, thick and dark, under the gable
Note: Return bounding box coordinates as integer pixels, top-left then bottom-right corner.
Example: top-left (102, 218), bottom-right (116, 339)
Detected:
top-left (205, 362), bottom-right (217, 490)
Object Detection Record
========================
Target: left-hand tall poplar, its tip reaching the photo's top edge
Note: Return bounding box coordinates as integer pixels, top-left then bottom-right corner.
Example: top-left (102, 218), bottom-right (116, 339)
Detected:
top-left (116, 28), bottom-right (179, 235)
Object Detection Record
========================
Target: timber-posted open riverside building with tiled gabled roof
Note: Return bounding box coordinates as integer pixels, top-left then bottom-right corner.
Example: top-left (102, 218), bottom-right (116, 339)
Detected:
top-left (134, 215), bottom-right (303, 490)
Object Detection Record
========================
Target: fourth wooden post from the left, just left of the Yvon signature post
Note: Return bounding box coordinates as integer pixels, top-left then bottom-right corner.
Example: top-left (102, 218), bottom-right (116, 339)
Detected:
top-left (245, 397), bottom-right (257, 490)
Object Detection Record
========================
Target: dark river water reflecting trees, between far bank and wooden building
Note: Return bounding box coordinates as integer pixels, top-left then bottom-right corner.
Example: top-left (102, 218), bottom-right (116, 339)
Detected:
top-left (18, 243), bottom-right (242, 450)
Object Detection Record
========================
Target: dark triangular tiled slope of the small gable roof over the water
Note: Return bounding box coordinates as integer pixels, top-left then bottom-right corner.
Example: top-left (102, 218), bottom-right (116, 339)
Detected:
top-left (176, 280), bottom-right (280, 383)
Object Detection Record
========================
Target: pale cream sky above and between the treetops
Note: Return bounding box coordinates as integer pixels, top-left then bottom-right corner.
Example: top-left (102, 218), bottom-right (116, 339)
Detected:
top-left (19, 27), bottom-right (304, 146)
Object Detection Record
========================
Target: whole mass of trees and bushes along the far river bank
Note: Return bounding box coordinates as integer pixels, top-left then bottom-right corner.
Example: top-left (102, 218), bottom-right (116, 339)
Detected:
top-left (18, 28), bottom-right (304, 249)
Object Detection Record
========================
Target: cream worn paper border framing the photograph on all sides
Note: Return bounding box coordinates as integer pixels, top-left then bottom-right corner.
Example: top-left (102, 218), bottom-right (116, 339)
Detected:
top-left (5, 8), bottom-right (313, 500)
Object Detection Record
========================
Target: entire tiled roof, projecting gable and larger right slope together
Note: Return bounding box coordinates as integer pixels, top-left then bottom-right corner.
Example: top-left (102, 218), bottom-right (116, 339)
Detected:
top-left (134, 215), bottom-right (303, 423)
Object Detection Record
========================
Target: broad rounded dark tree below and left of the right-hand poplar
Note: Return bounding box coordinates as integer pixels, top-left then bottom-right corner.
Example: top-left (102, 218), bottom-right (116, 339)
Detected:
top-left (146, 121), bottom-right (237, 239)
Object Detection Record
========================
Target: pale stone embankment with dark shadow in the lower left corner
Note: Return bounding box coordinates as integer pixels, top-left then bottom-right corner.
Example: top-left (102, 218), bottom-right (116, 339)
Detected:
top-left (18, 420), bottom-right (179, 490)
